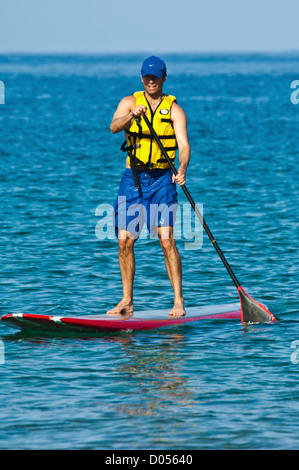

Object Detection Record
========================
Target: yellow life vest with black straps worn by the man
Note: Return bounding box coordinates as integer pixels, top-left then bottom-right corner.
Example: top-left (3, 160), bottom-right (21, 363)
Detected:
top-left (122, 91), bottom-right (178, 170)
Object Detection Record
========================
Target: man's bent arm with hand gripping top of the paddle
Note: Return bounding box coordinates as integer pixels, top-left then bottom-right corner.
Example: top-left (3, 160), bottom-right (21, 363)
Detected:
top-left (110, 96), bottom-right (146, 134)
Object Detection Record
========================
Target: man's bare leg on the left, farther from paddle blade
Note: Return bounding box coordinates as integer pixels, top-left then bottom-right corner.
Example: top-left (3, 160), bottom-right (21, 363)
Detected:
top-left (107, 230), bottom-right (136, 315)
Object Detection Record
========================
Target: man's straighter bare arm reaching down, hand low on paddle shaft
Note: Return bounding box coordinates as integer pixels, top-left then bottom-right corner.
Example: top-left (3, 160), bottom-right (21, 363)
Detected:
top-left (171, 103), bottom-right (190, 186)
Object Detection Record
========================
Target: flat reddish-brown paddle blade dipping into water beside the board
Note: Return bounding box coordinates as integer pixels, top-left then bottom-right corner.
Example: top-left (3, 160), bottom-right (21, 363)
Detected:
top-left (238, 286), bottom-right (276, 323)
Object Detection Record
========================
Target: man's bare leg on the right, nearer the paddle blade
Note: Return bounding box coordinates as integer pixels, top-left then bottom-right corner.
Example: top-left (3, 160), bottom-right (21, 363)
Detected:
top-left (158, 227), bottom-right (186, 316)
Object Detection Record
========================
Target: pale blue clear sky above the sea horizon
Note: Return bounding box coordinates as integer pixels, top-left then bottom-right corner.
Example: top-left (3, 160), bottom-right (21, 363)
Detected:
top-left (0, 0), bottom-right (299, 53)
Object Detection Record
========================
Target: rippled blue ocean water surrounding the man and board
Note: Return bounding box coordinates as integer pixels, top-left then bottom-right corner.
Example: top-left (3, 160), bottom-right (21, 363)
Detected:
top-left (0, 54), bottom-right (299, 451)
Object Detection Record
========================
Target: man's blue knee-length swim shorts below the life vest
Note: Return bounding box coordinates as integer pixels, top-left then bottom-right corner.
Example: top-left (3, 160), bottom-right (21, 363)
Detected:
top-left (114, 168), bottom-right (178, 238)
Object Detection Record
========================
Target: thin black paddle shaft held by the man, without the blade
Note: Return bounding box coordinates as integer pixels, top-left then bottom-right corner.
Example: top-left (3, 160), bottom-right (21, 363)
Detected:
top-left (143, 114), bottom-right (240, 288)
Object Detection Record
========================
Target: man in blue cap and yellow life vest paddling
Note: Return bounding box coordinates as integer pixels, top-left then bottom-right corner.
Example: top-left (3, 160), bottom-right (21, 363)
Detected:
top-left (107, 56), bottom-right (190, 316)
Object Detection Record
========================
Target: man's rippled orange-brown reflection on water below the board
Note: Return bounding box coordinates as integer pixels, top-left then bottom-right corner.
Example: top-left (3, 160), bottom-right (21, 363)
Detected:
top-left (116, 333), bottom-right (192, 415)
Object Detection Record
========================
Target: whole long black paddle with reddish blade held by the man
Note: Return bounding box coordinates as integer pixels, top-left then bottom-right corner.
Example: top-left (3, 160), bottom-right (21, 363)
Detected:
top-left (143, 114), bottom-right (276, 323)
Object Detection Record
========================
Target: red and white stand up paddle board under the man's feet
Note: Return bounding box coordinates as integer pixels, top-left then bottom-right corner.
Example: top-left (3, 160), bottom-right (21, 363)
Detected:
top-left (1, 303), bottom-right (241, 332)
